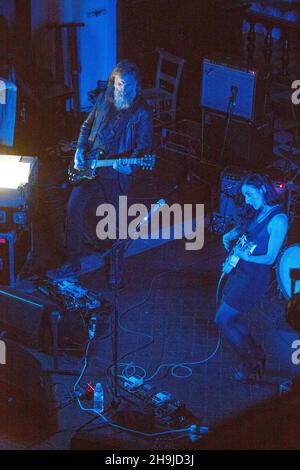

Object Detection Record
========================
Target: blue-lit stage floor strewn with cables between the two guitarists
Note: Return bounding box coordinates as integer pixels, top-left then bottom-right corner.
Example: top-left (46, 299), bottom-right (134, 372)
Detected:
top-left (0, 150), bottom-right (300, 449)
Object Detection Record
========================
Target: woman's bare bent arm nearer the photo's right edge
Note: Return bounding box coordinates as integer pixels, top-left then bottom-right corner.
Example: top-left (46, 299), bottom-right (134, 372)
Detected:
top-left (236, 214), bottom-right (288, 265)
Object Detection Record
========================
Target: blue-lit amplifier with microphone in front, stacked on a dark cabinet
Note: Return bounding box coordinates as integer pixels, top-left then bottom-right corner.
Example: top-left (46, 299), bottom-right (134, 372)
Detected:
top-left (200, 58), bottom-right (267, 121)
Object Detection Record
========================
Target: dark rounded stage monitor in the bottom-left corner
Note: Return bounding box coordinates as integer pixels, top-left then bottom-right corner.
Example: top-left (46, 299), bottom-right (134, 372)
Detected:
top-left (0, 338), bottom-right (57, 442)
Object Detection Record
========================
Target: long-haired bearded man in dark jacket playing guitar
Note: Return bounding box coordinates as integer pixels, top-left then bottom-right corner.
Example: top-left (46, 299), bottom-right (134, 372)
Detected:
top-left (51, 60), bottom-right (153, 282)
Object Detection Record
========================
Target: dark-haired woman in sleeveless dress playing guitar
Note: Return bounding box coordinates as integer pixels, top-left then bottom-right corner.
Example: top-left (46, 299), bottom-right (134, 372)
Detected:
top-left (215, 174), bottom-right (288, 383)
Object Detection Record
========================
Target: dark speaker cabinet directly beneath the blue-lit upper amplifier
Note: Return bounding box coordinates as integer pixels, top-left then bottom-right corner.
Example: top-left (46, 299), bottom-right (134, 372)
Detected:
top-left (202, 110), bottom-right (273, 169)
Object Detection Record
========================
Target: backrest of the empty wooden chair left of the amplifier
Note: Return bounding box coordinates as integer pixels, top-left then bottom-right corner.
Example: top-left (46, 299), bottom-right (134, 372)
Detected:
top-left (155, 48), bottom-right (185, 97)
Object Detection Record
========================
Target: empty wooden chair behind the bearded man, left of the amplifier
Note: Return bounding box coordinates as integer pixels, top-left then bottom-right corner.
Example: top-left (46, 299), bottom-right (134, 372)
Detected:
top-left (143, 49), bottom-right (185, 123)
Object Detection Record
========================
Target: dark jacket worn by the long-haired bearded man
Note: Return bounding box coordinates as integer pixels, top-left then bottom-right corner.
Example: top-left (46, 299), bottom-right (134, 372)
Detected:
top-left (77, 95), bottom-right (153, 157)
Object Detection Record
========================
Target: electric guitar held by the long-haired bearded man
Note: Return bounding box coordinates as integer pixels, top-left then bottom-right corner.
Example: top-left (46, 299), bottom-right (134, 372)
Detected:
top-left (68, 150), bottom-right (156, 185)
